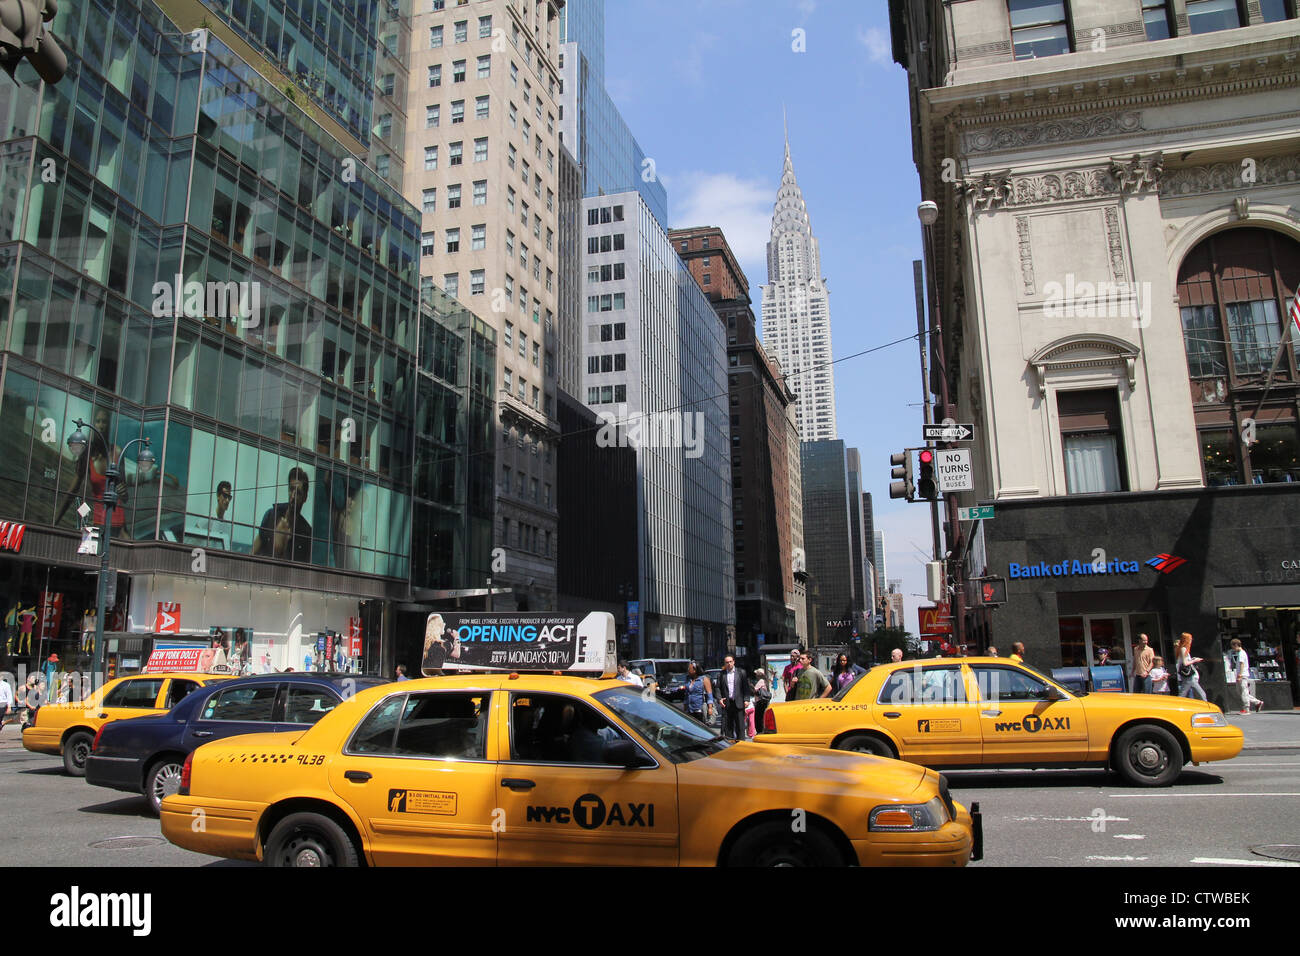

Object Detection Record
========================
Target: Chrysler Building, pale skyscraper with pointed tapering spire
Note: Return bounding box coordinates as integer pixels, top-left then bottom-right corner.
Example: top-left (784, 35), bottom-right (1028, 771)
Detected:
top-left (763, 125), bottom-right (839, 441)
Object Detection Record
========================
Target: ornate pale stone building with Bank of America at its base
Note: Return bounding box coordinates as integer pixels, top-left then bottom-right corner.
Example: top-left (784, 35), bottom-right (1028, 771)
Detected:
top-left (889, 0), bottom-right (1300, 706)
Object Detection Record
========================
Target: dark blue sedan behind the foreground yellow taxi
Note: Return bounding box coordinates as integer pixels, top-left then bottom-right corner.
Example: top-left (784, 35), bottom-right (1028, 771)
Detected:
top-left (86, 672), bottom-right (387, 814)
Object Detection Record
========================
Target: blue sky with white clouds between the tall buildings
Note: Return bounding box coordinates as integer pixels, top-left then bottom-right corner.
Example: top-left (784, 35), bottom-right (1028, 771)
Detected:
top-left (605, 0), bottom-right (932, 633)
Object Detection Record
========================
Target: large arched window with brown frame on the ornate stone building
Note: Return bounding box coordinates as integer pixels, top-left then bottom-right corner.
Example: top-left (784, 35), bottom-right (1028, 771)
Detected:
top-left (1178, 229), bottom-right (1300, 485)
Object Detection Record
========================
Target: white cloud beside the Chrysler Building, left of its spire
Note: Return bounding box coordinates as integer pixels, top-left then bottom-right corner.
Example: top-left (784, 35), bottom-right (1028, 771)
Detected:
top-left (660, 170), bottom-right (776, 274)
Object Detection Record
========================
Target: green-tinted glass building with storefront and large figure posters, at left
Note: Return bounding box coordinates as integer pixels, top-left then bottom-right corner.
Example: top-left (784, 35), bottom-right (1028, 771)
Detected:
top-left (0, 0), bottom-right (480, 670)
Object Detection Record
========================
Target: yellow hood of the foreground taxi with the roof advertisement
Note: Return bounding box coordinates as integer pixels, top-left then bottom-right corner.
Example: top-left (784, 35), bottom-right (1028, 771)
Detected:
top-left (677, 741), bottom-right (931, 800)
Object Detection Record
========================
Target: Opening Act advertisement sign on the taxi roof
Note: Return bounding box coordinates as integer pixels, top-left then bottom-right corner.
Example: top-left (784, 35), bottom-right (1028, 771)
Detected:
top-left (420, 611), bottom-right (618, 676)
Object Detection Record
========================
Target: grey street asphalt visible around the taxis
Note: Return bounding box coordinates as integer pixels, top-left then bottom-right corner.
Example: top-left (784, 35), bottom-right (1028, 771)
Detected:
top-left (0, 711), bottom-right (1300, 868)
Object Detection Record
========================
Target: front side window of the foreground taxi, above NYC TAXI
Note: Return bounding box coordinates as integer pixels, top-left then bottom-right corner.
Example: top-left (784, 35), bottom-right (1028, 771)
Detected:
top-left (510, 693), bottom-right (629, 763)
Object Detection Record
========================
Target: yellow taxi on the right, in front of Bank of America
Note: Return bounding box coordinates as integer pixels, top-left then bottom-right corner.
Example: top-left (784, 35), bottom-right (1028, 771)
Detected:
top-left (755, 657), bottom-right (1242, 787)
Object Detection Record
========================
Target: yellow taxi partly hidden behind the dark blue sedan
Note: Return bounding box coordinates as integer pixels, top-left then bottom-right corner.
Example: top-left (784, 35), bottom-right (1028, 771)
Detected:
top-left (22, 671), bottom-right (231, 777)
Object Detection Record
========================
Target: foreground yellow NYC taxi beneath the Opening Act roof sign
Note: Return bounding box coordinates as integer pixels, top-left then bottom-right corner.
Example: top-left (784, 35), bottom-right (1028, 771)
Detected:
top-left (160, 634), bottom-right (982, 866)
